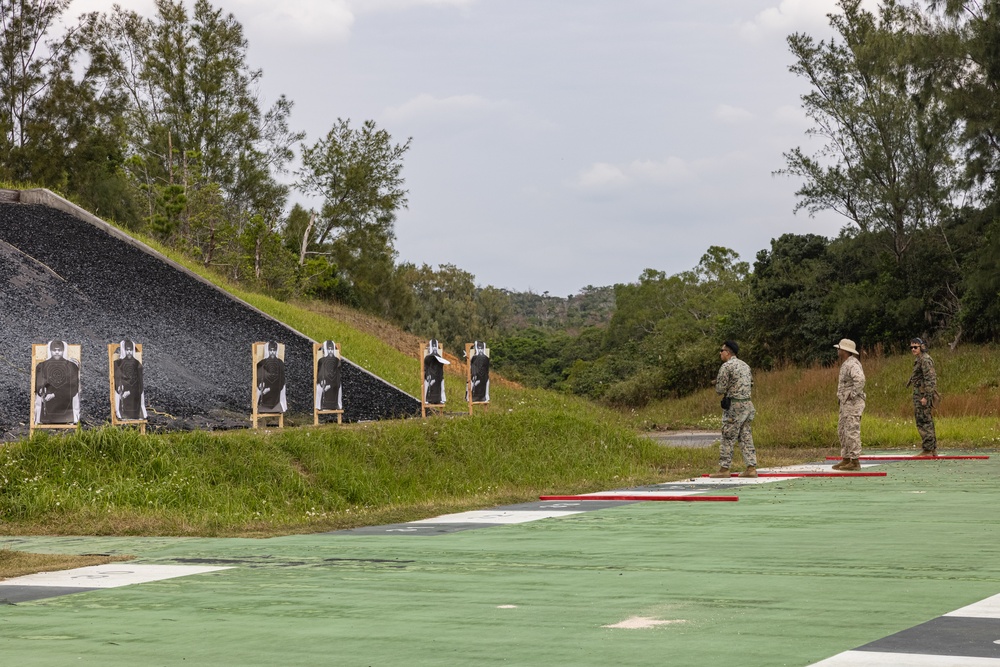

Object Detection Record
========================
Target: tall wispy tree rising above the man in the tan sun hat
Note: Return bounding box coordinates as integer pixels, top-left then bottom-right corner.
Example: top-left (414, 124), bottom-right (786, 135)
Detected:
top-left (778, 0), bottom-right (957, 261)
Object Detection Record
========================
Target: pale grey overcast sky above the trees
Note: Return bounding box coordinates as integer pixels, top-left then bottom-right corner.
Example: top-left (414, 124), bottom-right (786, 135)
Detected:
top-left (71, 0), bottom-right (868, 296)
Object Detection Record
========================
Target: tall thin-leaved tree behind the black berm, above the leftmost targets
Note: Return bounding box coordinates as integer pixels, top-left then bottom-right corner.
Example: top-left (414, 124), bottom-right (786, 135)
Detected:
top-left (86, 0), bottom-right (304, 230)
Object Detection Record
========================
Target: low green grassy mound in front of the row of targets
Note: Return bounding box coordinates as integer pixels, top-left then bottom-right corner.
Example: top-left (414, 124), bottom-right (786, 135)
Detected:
top-left (0, 388), bottom-right (711, 535)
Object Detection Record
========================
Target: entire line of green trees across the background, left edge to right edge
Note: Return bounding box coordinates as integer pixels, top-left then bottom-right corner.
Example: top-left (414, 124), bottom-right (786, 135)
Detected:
top-left (0, 0), bottom-right (1000, 405)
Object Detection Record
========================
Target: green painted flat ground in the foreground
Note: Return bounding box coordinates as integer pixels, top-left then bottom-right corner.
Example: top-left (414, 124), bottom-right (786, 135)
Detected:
top-left (0, 453), bottom-right (1000, 667)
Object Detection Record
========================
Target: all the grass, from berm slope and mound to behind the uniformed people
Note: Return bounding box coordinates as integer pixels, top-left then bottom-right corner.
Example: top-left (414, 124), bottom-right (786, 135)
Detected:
top-left (0, 201), bottom-right (1000, 536)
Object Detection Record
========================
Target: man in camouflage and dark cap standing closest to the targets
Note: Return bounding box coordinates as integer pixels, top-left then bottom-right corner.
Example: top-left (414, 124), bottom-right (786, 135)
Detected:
top-left (709, 340), bottom-right (757, 477)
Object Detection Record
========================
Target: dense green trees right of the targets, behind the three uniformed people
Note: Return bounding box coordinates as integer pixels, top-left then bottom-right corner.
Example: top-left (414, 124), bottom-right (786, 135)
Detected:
top-left (496, 0), bottom-right (1000, 405)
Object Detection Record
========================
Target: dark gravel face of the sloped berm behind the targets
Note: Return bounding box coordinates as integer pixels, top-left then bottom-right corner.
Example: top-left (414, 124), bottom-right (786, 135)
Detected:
top-left (0, 202), bottom-right (420, 439)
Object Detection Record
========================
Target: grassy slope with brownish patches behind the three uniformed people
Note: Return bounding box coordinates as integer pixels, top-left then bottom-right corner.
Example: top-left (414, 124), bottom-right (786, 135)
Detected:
top-left (631, 346), bottom-right (1000, 448)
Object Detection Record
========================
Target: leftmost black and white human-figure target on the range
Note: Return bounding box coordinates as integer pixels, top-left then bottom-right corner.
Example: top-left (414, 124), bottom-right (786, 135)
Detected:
top-left (32, 340), bottom-right (80, 424)
